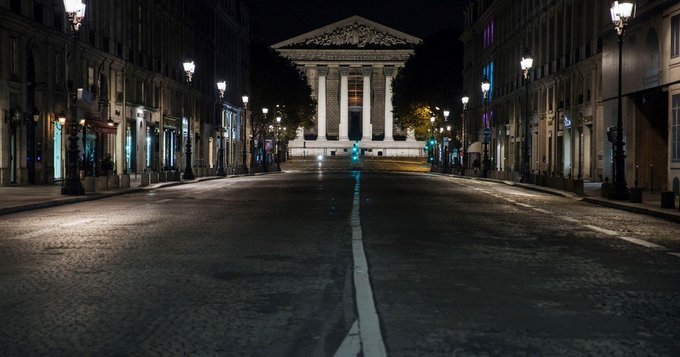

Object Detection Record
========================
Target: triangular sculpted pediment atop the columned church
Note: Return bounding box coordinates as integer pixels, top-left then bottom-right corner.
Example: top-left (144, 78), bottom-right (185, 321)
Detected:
top-left (272, 16), bottom-right (421, 49)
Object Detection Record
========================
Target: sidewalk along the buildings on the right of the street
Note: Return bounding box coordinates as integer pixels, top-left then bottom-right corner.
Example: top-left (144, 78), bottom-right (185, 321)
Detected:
top-left (453, 175), bottom-right (680, 223)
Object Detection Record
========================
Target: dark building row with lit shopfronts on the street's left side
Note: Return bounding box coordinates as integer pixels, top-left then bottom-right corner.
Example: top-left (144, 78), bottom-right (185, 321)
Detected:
top-left (0, 0), bottom-right (249, 185)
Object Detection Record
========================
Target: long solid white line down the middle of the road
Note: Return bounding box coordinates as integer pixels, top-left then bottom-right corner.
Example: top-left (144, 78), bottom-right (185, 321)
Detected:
top-left (341, 172), bottom-right (387, 357)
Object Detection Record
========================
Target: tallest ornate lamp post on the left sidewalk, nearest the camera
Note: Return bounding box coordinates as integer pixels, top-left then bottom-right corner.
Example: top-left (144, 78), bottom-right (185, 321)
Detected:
top-left (61, 0), bottom-right (86, 195)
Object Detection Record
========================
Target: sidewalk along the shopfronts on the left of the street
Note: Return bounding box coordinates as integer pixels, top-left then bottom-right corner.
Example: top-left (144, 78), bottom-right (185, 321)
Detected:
top-left (0, 172), bottom-right (275, 216)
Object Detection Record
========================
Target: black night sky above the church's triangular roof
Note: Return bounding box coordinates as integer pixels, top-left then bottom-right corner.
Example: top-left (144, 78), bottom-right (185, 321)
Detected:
top-left (247, 0), bottom-right (468, 45)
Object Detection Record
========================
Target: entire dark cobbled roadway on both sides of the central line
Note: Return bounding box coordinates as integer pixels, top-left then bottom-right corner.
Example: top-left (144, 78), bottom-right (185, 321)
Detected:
top-left (0, 171), bottom-right (680, 356)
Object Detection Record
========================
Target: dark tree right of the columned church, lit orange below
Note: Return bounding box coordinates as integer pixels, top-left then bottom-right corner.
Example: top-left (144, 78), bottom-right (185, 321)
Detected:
top-left (392, 29), bottom-right (463, 140)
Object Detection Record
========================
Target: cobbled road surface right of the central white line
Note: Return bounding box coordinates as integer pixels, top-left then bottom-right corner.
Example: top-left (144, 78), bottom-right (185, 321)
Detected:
top-left (361, 175), bottom-right (680, 356)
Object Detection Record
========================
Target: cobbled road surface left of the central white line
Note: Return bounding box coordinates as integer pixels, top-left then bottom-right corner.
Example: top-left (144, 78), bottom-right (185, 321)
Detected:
top-left (0, 174), bottom-right (355, 356)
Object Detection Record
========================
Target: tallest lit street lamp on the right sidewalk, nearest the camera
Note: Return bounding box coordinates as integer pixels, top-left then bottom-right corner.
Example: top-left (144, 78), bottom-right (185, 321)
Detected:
top-left (608, 1), bottom-right (635, 200)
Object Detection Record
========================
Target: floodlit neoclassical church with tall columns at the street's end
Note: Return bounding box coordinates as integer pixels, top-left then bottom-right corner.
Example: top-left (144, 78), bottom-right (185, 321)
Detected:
top-left (272, 16), bottom-right (424, 157)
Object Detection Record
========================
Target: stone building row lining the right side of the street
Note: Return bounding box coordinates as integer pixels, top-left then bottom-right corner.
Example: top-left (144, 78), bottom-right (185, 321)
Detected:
top-left (461, 0), bottom-right (680, 194)
